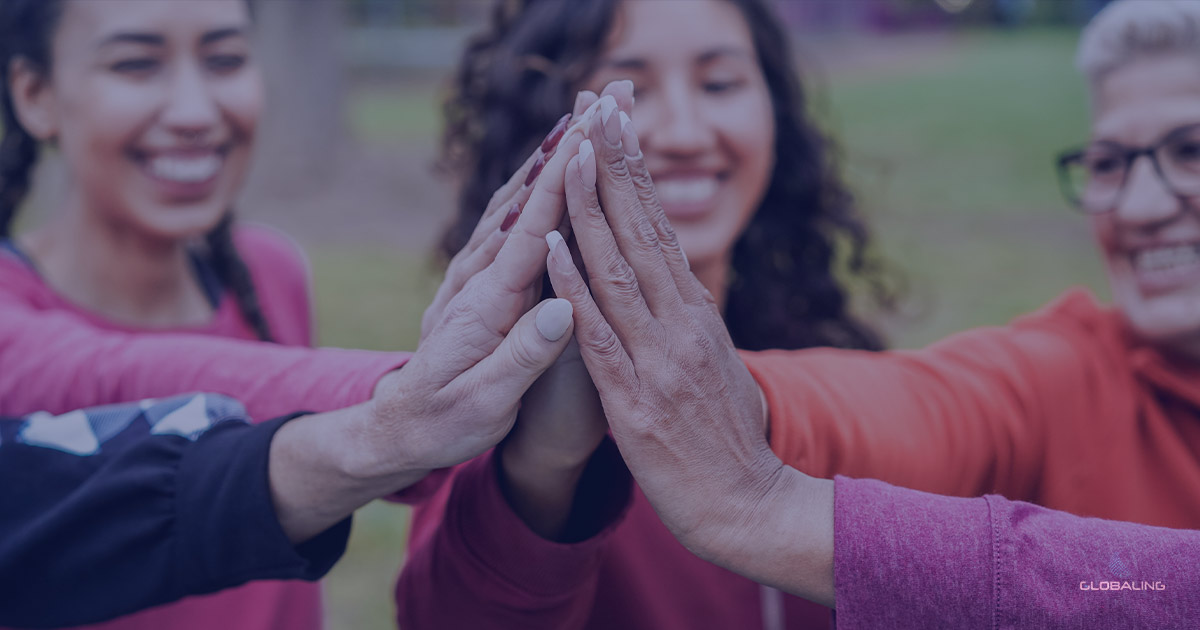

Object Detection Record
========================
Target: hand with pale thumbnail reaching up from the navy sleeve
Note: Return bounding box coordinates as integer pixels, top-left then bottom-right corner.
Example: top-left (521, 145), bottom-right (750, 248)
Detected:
top-left (348, 105), bottom-right (595, 475)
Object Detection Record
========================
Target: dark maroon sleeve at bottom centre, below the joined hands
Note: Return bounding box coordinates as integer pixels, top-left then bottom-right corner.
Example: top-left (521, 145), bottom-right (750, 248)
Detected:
top-left (396, 441), bottom-right (632, 630)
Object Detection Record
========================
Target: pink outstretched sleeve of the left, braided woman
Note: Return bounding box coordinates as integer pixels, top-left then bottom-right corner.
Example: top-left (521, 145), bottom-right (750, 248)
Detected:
top-left (0, 299), bottom-right (408, 420)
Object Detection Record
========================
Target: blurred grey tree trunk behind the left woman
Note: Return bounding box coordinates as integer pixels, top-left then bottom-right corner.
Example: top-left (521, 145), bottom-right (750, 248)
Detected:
top-left (252, 0), bottom-right (347, 196)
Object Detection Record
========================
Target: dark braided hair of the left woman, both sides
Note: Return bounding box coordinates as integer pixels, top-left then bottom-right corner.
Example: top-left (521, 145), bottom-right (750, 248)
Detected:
top-left (0, 0), bottom-right (272, 341)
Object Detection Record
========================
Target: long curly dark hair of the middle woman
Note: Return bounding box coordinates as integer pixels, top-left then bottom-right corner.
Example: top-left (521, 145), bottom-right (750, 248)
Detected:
top-left (440, 0), bottom-right (893, 350)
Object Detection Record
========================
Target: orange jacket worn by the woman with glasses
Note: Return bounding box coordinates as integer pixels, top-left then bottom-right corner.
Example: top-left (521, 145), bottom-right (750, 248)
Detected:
top-left (743, 289), bottom-right (1200, 528)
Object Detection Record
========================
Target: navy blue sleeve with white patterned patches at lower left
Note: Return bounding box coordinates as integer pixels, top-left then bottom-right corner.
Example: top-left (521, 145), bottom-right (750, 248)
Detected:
top-left (0, 394), bottom-right (350, 628)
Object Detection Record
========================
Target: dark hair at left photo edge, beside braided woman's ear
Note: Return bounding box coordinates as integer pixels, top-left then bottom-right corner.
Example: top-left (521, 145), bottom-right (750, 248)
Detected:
top-left (0, 0), bottom-right (62, 238)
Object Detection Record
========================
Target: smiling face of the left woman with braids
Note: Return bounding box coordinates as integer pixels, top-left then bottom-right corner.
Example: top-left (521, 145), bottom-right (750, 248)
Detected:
top-left (21, 0), bottom-right (263, 240)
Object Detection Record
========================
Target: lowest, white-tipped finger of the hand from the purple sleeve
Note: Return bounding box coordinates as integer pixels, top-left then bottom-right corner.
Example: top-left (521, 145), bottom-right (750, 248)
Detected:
top-left (546, 232), bottom-right (634, 395)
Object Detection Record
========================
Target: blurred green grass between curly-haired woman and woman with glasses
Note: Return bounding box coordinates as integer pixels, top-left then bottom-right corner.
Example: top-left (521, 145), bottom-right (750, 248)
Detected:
top-left (822, 31), bottom-right (1104, 347)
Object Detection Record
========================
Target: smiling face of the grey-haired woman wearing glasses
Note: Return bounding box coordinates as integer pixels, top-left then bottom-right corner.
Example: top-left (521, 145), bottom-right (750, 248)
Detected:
top-left (1092, 54), bottom-right (1200, 358)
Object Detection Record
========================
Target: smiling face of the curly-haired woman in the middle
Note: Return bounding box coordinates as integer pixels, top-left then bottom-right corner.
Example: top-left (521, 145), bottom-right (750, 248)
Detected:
top-left (587, 0), bottom-right (775, 274)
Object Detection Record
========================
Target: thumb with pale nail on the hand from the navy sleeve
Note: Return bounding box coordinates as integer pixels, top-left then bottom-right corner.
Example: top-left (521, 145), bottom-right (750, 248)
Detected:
top-left (464, 298), bottom-right (575, 401)
